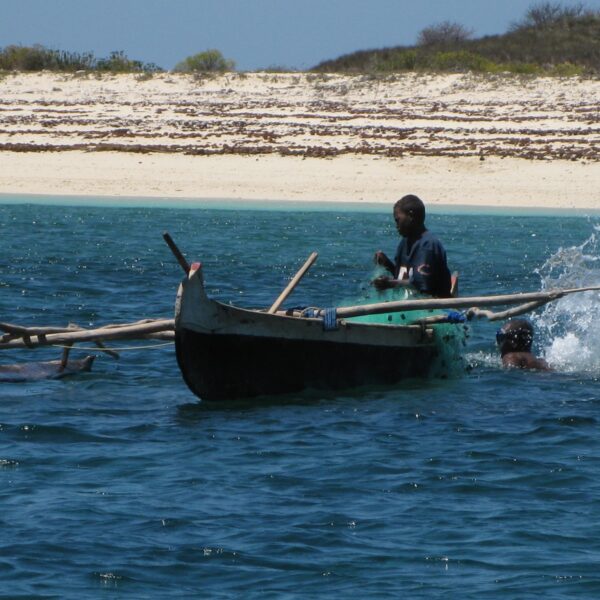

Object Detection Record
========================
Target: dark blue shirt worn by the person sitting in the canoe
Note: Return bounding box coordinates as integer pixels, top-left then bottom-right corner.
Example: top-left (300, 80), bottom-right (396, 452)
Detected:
top-left (394, 230), bottom-right (451, 298)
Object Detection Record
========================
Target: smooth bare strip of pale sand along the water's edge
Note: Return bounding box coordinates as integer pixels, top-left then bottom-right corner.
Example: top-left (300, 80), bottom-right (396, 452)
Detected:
top-left (0, 151), bottom-right (600, 211)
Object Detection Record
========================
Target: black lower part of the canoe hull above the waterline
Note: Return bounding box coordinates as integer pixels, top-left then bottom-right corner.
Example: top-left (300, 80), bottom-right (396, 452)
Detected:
top-left (175, 328), bottom-right (436, 401)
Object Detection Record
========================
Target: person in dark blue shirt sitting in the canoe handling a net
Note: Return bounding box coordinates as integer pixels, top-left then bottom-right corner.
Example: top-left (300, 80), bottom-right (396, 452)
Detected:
top-left (373, 194), bottom-right (452, 298)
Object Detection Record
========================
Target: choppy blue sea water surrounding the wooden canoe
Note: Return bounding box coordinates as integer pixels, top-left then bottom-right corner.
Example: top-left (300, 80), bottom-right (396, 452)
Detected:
top-left (0, 199), bottom-right (600, 599)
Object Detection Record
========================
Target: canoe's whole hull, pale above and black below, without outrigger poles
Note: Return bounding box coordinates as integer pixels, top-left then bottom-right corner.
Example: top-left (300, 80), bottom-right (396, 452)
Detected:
top-left (175, 263), bottom-right (439, 401)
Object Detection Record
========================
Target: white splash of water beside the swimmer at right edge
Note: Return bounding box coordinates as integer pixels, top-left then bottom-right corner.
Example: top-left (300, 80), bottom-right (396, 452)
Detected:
top-left (532, 226), bottom-right (600, 373)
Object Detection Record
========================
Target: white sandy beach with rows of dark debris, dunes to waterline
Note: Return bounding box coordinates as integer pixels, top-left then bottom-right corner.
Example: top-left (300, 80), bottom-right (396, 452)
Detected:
top-left (0, 73), bottom-right (600, 208)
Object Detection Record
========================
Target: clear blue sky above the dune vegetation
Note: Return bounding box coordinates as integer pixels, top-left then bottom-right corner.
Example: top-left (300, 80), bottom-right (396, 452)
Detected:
top-left (0, 0), bottom-right (600, 70)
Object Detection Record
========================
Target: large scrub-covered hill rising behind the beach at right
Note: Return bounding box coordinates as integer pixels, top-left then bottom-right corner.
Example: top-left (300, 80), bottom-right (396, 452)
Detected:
top-left (314, 2), bottom-right (600, 75)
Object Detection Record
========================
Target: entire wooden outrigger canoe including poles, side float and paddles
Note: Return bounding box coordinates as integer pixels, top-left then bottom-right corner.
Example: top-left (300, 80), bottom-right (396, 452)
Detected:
top-left (0, 234), bottom-right (600, 402)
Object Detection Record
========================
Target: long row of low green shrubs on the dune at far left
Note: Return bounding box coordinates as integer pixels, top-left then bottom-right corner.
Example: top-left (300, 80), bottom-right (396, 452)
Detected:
top-left (0, 44), bottom-right (162, 73)
